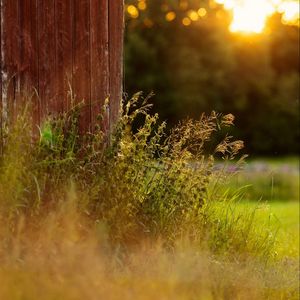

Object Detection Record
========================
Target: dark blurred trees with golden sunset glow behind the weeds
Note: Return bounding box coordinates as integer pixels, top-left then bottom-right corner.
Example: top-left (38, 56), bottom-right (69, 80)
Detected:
top-left (125, 0), bottom-right (300, 156)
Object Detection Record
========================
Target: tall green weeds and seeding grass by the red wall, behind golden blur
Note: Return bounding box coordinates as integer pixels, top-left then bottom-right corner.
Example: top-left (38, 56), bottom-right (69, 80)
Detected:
top-left (0, 94), bottom-right (274, 260)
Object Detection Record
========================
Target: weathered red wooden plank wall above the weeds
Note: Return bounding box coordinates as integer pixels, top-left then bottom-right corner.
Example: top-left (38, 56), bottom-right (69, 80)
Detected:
top-left (0, 0), bottom-right (123, 129)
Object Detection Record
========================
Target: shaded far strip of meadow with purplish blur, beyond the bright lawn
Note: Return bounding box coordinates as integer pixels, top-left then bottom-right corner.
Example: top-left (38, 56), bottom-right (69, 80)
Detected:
top-left (224, 157), bottom-right (300, 202)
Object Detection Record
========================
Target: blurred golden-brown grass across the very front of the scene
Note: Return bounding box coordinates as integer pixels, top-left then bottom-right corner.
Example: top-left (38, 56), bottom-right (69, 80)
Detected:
top-left (0, 200), bottom-right (297, 300)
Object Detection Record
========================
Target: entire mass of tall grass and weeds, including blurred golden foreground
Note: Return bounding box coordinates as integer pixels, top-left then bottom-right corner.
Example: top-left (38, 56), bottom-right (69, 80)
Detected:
top-left (0, 94), bottom-right (297, 299)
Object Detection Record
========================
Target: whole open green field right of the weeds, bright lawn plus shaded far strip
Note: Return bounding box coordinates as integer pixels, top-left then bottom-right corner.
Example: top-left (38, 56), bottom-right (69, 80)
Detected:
top-left (233, 157), bottom-right (299, 257)
